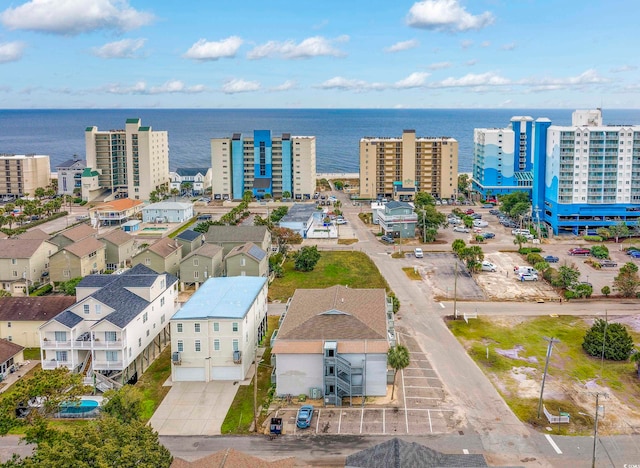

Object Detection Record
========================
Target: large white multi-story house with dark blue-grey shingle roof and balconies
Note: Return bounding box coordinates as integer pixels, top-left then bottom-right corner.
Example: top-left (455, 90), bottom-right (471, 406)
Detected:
top-left (40, 265), bottom-right (178, 383)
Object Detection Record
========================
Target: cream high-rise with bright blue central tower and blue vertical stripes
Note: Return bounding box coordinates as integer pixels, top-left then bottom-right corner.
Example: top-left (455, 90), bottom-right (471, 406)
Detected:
top-left (211, 130), bottom-right (316, 200)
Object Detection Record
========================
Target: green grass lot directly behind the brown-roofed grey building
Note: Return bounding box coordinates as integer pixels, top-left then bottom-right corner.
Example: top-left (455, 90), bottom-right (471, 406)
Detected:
top-left (269, 252), bottom-right (388, 301)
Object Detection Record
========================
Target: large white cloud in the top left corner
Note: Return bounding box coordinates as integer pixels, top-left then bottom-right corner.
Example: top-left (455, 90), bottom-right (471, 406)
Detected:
top-left (0, 0), bottom-right (155, 36)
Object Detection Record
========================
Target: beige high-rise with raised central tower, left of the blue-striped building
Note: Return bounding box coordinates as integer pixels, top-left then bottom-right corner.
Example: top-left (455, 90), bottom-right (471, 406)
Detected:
top-left (85, 119), bottom-right (169, 200)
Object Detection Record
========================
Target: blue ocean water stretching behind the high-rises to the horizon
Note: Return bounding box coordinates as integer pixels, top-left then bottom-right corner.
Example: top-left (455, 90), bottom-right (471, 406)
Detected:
top-left (0, 109), bottom-right (640, 172)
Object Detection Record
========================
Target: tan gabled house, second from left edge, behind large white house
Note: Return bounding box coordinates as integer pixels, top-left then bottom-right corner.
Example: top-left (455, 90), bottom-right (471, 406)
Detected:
top-left (49, 237), bottom-right (107, 282)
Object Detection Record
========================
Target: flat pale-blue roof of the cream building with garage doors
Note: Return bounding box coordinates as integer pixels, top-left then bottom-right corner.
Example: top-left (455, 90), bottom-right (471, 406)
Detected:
top-left (171, 276), bottom-right (267, 321)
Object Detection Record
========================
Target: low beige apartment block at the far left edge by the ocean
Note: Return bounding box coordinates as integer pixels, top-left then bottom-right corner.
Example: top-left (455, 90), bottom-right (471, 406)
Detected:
top-left (0, 154), bottom-right (51, 198)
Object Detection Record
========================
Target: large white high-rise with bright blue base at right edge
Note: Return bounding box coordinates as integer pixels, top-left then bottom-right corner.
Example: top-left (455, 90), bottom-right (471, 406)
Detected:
top-left (532, 109), bottom-right (640, 234)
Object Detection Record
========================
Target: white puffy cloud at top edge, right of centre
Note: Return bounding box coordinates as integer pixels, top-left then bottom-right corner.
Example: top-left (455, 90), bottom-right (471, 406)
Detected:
top-left (407, 0), bottom-right (494, 32)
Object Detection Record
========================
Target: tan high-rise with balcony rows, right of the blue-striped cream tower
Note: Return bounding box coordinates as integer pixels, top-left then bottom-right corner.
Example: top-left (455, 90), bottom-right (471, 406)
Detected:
top-left (360, 130), bottom-right (458, 201)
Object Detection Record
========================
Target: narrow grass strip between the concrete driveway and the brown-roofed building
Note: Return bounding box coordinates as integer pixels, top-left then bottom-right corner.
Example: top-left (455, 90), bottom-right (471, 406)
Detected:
top-left (221, 316), bottom-right (279, 434)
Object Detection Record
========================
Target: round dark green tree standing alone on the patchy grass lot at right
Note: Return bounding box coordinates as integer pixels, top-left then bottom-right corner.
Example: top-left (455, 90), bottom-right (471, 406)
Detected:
top-left (582, 319), bottom-right (633, 361)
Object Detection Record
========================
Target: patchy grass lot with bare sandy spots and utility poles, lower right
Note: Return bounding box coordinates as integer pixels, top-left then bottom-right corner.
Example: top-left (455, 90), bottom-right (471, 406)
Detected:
top-left (448, 316), bottom-right (640, 434)
